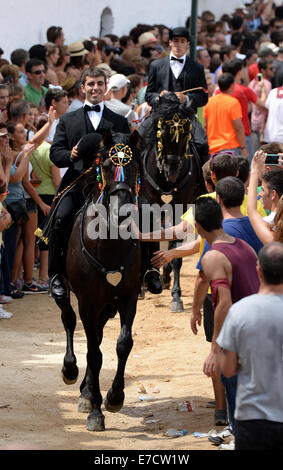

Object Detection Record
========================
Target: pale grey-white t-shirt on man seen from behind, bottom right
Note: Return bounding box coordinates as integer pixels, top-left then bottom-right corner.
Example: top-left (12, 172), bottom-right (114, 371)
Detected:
top-left (219, 294), bottom-right (283, 423)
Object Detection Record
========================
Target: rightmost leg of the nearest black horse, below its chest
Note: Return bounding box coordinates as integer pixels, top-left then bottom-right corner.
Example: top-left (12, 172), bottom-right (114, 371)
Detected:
top-left (104, 292), bottom-right (138, 413)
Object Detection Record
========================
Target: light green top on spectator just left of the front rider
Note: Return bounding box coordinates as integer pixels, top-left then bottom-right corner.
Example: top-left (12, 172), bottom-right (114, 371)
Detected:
top-left (30, 142), bottom-right (56, 195)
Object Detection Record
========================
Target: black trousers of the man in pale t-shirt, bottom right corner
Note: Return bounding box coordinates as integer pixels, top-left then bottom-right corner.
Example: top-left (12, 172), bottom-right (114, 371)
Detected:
top-left (235, 419), bottom-right (283, 450)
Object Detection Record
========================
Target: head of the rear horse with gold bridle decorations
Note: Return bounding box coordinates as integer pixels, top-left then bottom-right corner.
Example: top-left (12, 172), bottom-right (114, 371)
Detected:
top-left (152, 93), bottom-right (194, 183)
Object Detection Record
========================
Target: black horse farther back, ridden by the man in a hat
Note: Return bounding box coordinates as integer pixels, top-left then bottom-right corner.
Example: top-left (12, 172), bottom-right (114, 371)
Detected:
top-left (140, 93), bottom-right (209, 312)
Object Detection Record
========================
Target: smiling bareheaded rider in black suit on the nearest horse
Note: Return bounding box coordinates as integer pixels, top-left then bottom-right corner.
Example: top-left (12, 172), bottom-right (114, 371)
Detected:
top-left (48, 68), bottom-right (130, 299)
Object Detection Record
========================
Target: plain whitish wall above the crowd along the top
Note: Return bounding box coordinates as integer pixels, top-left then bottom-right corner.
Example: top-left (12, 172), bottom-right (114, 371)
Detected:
top-left (0, 0), bottom-right (278, 60)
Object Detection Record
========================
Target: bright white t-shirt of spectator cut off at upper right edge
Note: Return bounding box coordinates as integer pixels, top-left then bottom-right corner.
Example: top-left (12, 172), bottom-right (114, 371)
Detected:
top-left (263, 87), bottom-right (283, 144)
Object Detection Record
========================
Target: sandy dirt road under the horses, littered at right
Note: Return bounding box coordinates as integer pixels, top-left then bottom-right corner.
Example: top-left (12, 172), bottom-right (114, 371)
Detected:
top-left (0, 253), bottom-right (221, 450)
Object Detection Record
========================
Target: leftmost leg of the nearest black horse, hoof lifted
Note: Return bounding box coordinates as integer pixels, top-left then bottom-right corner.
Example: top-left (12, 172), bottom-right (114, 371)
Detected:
top-left (56, 293), bottom-right (79, 385)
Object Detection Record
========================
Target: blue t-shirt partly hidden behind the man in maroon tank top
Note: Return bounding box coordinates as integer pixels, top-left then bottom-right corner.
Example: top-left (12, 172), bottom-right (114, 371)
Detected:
top-left (196, 216), bottom-right (263, 271)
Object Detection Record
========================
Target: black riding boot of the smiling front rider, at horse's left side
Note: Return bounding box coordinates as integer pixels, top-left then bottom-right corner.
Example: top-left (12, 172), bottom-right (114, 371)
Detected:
top-left (48, 219), bottom-right (68, 300)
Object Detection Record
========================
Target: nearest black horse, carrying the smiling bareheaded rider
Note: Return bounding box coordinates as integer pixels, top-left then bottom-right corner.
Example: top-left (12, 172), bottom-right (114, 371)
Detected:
top-left (56, 132), bottom-right (141, 431)
